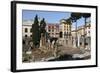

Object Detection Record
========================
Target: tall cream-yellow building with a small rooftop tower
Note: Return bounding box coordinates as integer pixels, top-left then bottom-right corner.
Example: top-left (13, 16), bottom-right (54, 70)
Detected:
top-left (59, 19), bottom-right (71, 45)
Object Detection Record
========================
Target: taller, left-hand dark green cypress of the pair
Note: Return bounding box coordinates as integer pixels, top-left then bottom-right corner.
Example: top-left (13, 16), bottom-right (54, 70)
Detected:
top-left (32, 15), bottom-right (40, 47)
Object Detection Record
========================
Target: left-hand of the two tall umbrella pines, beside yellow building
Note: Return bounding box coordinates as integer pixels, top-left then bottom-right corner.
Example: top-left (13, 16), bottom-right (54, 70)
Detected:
top-left (71, 13), bottom-right (81, 47)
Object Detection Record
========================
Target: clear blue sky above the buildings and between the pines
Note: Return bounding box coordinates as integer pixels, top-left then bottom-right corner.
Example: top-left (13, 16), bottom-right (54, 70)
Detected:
top-left (22, 10), bottom-right (90, 27)
